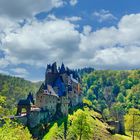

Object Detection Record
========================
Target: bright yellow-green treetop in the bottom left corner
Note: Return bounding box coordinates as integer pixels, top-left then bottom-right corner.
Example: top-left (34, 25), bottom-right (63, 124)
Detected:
top-left (0, 120), bottom-right (32, 140)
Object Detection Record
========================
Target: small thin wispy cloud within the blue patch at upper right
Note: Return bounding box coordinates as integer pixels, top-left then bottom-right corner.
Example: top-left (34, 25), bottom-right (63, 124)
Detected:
top-left (93, 9), bottom-right (117, 22)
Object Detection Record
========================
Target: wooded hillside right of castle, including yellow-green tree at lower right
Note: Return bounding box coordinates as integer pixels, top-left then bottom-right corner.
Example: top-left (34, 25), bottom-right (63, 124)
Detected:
top-left (82, 70), bottom-right (140, 137)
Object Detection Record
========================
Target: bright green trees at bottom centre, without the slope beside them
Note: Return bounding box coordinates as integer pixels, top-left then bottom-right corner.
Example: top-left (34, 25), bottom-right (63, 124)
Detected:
top-left (44, 109), bottom-right (94, 140)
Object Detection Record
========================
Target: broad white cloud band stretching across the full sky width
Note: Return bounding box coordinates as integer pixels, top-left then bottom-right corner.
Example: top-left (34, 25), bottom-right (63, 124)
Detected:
top-left (0, 14), bottom-right (140, 69)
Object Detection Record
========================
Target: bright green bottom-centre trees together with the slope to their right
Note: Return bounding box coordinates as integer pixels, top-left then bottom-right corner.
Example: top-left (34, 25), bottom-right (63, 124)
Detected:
top-left (43, 108), bottom-right (119, 140)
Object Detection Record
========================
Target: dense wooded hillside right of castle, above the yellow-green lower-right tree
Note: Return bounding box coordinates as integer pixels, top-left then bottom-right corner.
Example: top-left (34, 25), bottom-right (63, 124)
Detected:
top-left (82, 70), bottom-right (140, 112)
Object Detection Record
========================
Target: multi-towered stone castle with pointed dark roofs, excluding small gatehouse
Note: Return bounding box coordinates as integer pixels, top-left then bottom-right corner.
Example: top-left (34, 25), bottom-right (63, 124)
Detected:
top-left (36, 62), bottom-right (82, 116)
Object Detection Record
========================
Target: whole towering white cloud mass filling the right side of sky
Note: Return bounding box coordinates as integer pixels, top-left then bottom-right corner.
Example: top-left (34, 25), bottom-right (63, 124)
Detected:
top-left (77, 14), bottom-right (140, 69)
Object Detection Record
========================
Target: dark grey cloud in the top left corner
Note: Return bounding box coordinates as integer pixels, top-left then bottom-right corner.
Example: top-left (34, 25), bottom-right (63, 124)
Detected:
top-left (0, 0), bottom-right (64, 19)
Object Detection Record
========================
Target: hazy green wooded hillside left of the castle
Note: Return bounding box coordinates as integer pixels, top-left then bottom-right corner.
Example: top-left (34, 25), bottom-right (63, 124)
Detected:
top-left (0, 74), bottom-right (40, 116)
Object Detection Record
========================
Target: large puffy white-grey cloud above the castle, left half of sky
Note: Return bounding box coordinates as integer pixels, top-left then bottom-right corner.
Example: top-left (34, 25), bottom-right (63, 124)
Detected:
top-left (2, 19), bottom-right (80, 66)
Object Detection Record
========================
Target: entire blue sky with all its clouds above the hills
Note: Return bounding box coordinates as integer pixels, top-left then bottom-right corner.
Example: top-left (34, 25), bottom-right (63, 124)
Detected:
top-left (0, 0), bottom-right (140, 81)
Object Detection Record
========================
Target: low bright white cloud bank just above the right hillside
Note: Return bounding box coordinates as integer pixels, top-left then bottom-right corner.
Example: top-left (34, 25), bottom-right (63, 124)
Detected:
top-left (92, 46), bottom-right (140, 69)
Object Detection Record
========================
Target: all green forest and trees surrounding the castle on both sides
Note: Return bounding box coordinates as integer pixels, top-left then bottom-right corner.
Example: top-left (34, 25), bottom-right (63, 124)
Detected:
top-left (0, 68), bottom-right (140, 140)
